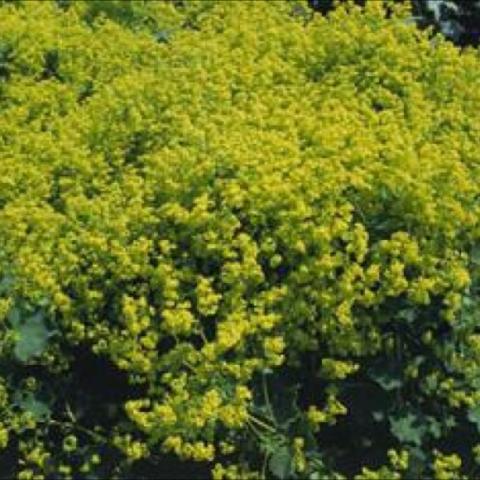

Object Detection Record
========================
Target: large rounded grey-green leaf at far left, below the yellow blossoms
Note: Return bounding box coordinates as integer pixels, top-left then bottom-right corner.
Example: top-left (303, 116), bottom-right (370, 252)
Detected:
top-left (12, 313), bottom-right (52, 362)
